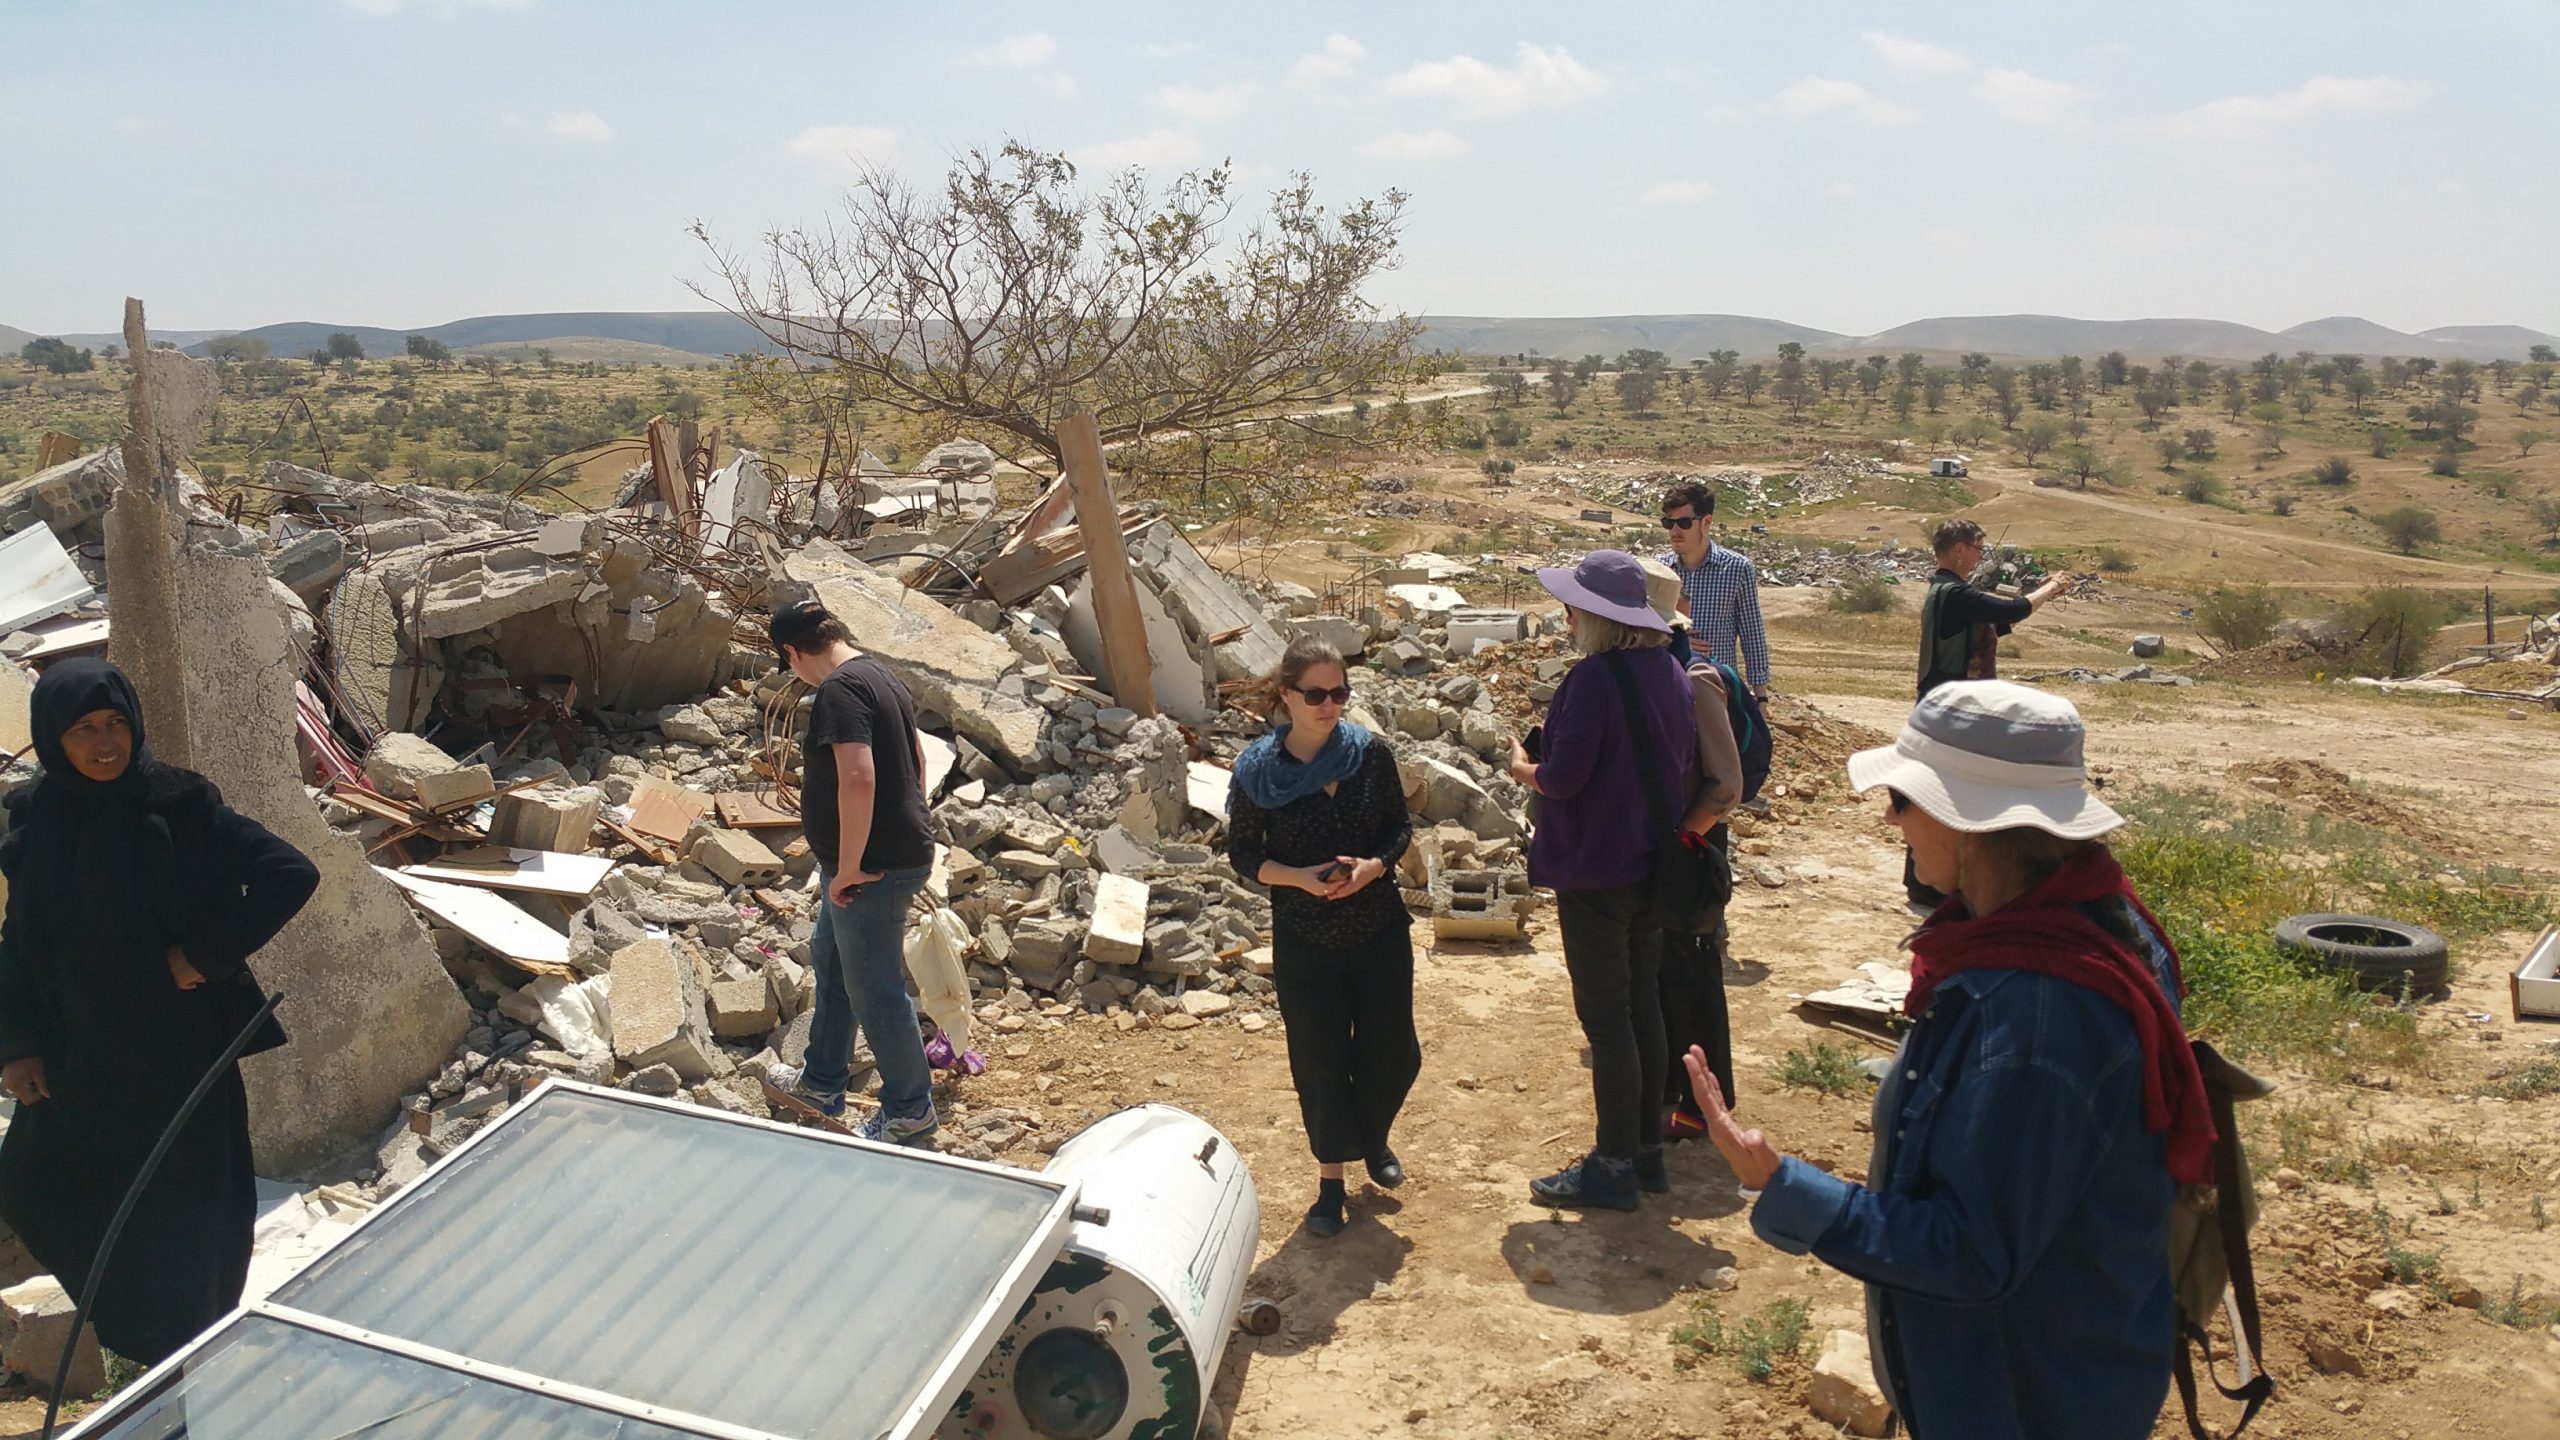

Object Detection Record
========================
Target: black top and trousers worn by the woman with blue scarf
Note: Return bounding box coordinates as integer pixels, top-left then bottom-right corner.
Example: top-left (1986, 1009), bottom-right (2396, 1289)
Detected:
top-left (1226, 738), bottom-right (1423, 1166)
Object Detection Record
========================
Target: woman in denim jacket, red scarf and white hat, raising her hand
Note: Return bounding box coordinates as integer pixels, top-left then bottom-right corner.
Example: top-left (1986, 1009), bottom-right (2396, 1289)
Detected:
top-left (1687, 679), bottom-right (2214, 1440)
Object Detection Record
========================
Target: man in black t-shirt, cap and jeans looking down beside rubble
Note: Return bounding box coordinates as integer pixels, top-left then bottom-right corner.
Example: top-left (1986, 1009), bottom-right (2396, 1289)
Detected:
top-left (765, 600), bottom-right (940, 1145)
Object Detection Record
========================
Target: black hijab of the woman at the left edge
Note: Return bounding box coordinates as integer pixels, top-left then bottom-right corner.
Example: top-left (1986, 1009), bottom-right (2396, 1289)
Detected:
top-left (0, 656), bottom-right (189, 956)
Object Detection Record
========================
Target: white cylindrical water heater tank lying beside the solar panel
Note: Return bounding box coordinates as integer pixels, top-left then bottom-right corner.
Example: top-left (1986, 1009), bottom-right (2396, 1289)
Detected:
top-left (937, 1104), bottom-right (1262, 1440)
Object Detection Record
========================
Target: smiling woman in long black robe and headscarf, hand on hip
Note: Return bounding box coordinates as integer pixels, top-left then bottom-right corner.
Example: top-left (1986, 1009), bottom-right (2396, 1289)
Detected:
top-left (0, 659), bottom-right (320, 1363)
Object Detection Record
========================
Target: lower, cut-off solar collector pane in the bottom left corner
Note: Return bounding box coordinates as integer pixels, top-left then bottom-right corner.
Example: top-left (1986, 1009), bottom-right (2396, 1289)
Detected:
top-left (86, 1314), bottom-right (689, 1440)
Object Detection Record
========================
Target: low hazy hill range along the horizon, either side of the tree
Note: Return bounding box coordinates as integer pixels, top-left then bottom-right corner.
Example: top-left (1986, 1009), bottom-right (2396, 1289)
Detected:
top-left (0, 310), bottom-right (2560, 364)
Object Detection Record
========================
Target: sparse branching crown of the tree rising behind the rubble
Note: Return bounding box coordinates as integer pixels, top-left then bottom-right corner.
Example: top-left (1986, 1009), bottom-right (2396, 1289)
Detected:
top-left (694, 141), bottom-right (1428, 502)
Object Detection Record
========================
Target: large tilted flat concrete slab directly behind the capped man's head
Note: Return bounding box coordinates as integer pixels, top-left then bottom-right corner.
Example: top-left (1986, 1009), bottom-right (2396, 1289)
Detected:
top-left (773, 541), bottom-right (1047, 774)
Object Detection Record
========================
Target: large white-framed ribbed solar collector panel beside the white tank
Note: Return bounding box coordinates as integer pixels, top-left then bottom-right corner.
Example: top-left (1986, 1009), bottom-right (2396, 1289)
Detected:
top-left (269, 1086), bottom-right (1065, 1440)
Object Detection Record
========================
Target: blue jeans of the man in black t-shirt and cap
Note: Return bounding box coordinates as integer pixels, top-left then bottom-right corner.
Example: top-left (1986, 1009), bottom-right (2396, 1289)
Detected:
top-left (801, 866), bottom-right (934, 1120)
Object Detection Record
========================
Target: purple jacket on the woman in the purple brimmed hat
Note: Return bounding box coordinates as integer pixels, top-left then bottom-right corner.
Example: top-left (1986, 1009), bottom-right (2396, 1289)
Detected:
top-left (1528, 638), bottom-right (1697, 889)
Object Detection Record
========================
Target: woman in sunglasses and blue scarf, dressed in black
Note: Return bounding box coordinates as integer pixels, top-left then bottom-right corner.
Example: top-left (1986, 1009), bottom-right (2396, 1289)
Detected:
top-left (1226, 635), bottom-right (1423, 1235)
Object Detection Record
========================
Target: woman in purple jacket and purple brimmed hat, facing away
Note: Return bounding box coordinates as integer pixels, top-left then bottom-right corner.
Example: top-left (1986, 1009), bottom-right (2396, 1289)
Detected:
top-left (1510, 551), bottom-right (1697, 1209)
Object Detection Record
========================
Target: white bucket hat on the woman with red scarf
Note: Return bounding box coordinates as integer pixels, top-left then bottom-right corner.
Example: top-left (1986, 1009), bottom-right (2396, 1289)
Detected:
top-left (1848, 679), bottom-right (2125, 840)
